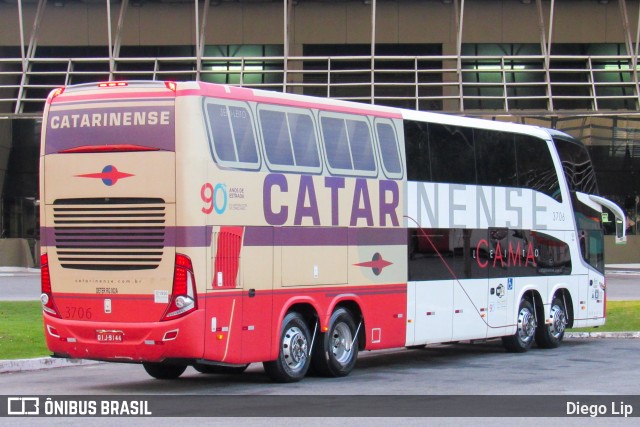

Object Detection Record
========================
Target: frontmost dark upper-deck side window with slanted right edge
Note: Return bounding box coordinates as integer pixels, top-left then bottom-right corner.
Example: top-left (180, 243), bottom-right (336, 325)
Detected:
top-left (515, 135), bottom-right (562, 201)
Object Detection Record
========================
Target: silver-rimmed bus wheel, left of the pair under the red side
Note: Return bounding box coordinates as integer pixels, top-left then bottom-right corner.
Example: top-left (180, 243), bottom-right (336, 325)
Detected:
top-left (263, 312), bottom-right (311, 383)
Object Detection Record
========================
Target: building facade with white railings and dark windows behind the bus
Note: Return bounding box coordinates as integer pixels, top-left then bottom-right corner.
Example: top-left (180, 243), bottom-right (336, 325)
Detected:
top-left (0, 0), bottom-right (640, 264)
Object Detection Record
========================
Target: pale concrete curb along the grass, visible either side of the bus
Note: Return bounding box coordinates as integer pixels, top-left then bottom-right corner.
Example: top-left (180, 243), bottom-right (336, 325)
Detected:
top-left (0, 332), bottom-right (640, 374)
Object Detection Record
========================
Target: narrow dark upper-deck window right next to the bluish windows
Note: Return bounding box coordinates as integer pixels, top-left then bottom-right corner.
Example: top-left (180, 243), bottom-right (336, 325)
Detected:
top-left (404, 120), bottom-right (431, 182)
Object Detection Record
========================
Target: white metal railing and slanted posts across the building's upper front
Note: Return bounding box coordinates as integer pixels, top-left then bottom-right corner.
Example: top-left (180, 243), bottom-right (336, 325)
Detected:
top-left (0, 0), bottom-right (640, 115)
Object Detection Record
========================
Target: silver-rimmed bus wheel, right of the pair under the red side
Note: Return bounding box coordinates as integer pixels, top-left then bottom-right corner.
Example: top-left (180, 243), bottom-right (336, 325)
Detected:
top-left (311, 307), bottom-right (358, 377)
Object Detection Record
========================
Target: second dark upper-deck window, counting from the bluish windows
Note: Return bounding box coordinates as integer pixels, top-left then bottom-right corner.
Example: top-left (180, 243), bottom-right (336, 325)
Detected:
top-left (429, 123), bottom-right (476, 184)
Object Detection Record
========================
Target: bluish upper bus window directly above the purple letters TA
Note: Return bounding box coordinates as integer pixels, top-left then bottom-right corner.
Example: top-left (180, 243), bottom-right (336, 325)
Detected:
top-left (320, 114), bottom-right (376, 176)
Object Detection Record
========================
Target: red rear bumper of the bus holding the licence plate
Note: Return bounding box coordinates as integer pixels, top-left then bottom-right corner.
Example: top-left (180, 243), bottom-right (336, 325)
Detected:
top-left (44, 310), bottom-right (204, 363)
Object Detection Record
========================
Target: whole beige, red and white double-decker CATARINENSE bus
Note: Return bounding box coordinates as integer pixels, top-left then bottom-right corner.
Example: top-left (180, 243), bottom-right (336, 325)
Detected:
top-left (40, 81), bottom-right (624, 382)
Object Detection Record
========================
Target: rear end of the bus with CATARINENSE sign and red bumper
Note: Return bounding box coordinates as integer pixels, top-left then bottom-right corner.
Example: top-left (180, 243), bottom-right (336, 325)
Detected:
top-left (40, 82), bottom-right (203, 368)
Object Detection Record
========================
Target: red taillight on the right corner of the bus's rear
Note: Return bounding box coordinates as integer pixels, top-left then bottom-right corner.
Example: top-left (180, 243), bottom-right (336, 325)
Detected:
top-left (162, 254), bottom-right (198, 320)
